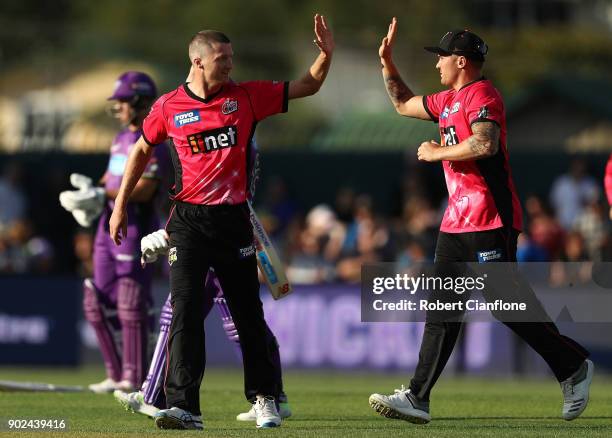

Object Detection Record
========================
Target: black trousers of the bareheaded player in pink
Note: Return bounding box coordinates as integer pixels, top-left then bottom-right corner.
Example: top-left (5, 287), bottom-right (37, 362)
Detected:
top-left (165, 202), bottom-right (280, 415)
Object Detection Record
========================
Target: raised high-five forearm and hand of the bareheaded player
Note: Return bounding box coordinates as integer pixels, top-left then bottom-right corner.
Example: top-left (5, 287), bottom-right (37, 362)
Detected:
top-left (288, 14), bottom-right (334, 99)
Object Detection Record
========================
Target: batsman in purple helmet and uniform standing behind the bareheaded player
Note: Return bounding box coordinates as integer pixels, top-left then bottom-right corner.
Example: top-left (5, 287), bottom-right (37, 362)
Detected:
top-left (83, 72), bottom-right (168, 392)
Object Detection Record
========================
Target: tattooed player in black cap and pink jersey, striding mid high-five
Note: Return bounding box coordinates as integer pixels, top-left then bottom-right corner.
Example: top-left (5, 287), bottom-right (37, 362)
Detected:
top-left (369, 18), bottom-right (593, 424)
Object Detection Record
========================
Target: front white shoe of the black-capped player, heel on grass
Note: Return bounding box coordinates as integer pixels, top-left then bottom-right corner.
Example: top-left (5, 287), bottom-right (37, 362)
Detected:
top-left (369, 385), bottom-right (431, 424)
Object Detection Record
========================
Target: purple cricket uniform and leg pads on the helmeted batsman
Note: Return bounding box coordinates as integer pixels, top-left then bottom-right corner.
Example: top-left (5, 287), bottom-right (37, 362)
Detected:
top-left (84, 129), bottom-right (168, 387)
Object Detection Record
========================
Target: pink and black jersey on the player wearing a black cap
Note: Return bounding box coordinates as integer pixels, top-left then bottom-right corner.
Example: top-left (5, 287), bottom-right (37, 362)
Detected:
top-left (423, 78), bottom-right (523, 233)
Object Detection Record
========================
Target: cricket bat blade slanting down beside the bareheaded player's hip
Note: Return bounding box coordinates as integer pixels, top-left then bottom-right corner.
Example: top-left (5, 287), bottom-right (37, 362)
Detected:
top-left (248, 202), bottom-right (292, 300)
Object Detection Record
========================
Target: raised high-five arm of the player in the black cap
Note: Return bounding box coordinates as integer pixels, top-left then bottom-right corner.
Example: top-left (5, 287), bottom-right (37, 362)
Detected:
top-left (378, 17), bottom-right (431, 120)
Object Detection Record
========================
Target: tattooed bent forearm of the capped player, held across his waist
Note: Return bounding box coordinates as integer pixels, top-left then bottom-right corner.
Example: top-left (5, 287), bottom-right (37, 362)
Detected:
top-left (417, 121), bottom-right (499, 161)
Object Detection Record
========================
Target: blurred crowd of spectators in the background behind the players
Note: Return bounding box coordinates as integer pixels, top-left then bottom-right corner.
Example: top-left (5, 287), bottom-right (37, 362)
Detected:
top-left (0, 159), bottom-right (612, 284)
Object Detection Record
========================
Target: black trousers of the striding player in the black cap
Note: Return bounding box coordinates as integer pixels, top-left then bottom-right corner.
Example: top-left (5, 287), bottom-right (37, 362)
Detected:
top-left (410, 228), bottom-right (589, 400)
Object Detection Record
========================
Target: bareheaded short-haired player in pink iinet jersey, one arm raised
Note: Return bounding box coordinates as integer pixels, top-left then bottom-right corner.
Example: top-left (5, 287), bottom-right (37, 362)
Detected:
top-left (109, 14), bottom-right (334, 429)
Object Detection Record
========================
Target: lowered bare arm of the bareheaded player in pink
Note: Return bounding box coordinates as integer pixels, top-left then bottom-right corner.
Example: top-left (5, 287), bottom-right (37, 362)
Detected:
top-left (109, 136), bottom-right (153, 245)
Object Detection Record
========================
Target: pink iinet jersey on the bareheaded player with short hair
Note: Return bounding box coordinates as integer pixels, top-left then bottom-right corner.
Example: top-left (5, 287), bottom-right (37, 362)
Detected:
top-left (143, 81), bottom-right (289, 205)
